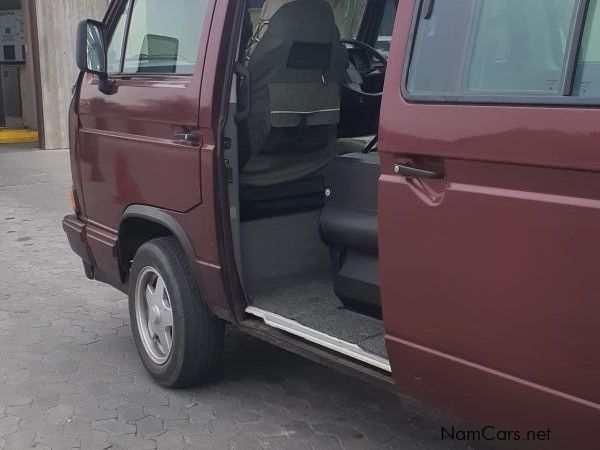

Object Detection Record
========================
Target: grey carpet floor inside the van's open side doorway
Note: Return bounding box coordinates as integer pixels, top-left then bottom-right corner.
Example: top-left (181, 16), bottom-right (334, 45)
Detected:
top-left (250, 278), bottom-right (387, 358)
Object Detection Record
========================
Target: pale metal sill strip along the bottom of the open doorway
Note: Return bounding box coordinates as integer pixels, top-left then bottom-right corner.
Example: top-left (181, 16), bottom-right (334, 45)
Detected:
top-left (246, 306), bottom-right (392, 372)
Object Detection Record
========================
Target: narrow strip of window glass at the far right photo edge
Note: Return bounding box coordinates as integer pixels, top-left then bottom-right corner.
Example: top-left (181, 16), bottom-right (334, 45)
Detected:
top-left (573, 0), bottom-right (600, 97)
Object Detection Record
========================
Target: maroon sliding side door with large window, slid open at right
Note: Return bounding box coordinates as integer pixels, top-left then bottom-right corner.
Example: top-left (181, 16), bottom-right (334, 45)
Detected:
top-left (379, 0), bottom-right (600, 448)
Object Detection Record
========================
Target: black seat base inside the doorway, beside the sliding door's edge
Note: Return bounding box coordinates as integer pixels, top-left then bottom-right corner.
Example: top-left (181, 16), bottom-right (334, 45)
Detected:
top-left (320, 153), bottom-right (381, 316)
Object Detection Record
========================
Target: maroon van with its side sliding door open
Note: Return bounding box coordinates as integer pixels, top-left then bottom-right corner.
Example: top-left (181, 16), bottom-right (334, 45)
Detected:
top-left (63, 0), bottom-right (600, 449)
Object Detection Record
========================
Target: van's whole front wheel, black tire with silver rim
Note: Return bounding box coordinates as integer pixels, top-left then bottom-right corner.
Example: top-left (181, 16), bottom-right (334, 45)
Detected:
top-left (129, 237), bottom-right (225, 388)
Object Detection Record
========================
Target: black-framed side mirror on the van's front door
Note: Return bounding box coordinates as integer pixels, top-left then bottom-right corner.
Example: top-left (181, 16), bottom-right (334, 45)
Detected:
top-left (77, 20), bottom-right (106, 77)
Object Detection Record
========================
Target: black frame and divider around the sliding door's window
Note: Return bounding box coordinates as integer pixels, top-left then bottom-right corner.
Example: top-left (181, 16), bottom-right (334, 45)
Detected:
top-left (401, 0), bottom-right (600, 107)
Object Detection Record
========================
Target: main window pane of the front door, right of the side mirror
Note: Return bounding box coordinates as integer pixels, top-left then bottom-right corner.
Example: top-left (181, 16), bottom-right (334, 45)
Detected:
top-left (123, 0), bottom-right (208, 75)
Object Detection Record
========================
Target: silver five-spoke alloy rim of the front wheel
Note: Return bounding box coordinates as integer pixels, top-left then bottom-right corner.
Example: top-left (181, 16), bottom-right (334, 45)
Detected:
top-left (135, 267), bottom-right (174, 366)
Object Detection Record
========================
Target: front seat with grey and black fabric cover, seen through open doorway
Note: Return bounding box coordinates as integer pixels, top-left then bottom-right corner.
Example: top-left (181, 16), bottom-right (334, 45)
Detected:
top-left (240, 0), bottom-right (348, 216)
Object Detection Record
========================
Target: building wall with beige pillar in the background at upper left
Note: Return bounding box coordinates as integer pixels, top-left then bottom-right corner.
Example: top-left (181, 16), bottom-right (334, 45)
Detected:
top-left (0, 0), bottom-right (109, 149)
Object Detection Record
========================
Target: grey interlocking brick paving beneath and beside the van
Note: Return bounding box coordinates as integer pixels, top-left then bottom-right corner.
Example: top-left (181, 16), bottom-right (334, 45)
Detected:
top-left (0, 147), bottom-right (496, 450)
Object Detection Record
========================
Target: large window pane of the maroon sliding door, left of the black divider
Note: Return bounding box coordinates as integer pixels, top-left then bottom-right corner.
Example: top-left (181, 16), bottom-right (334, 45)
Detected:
top-left (408, 0), bottom-right (576, 95)
